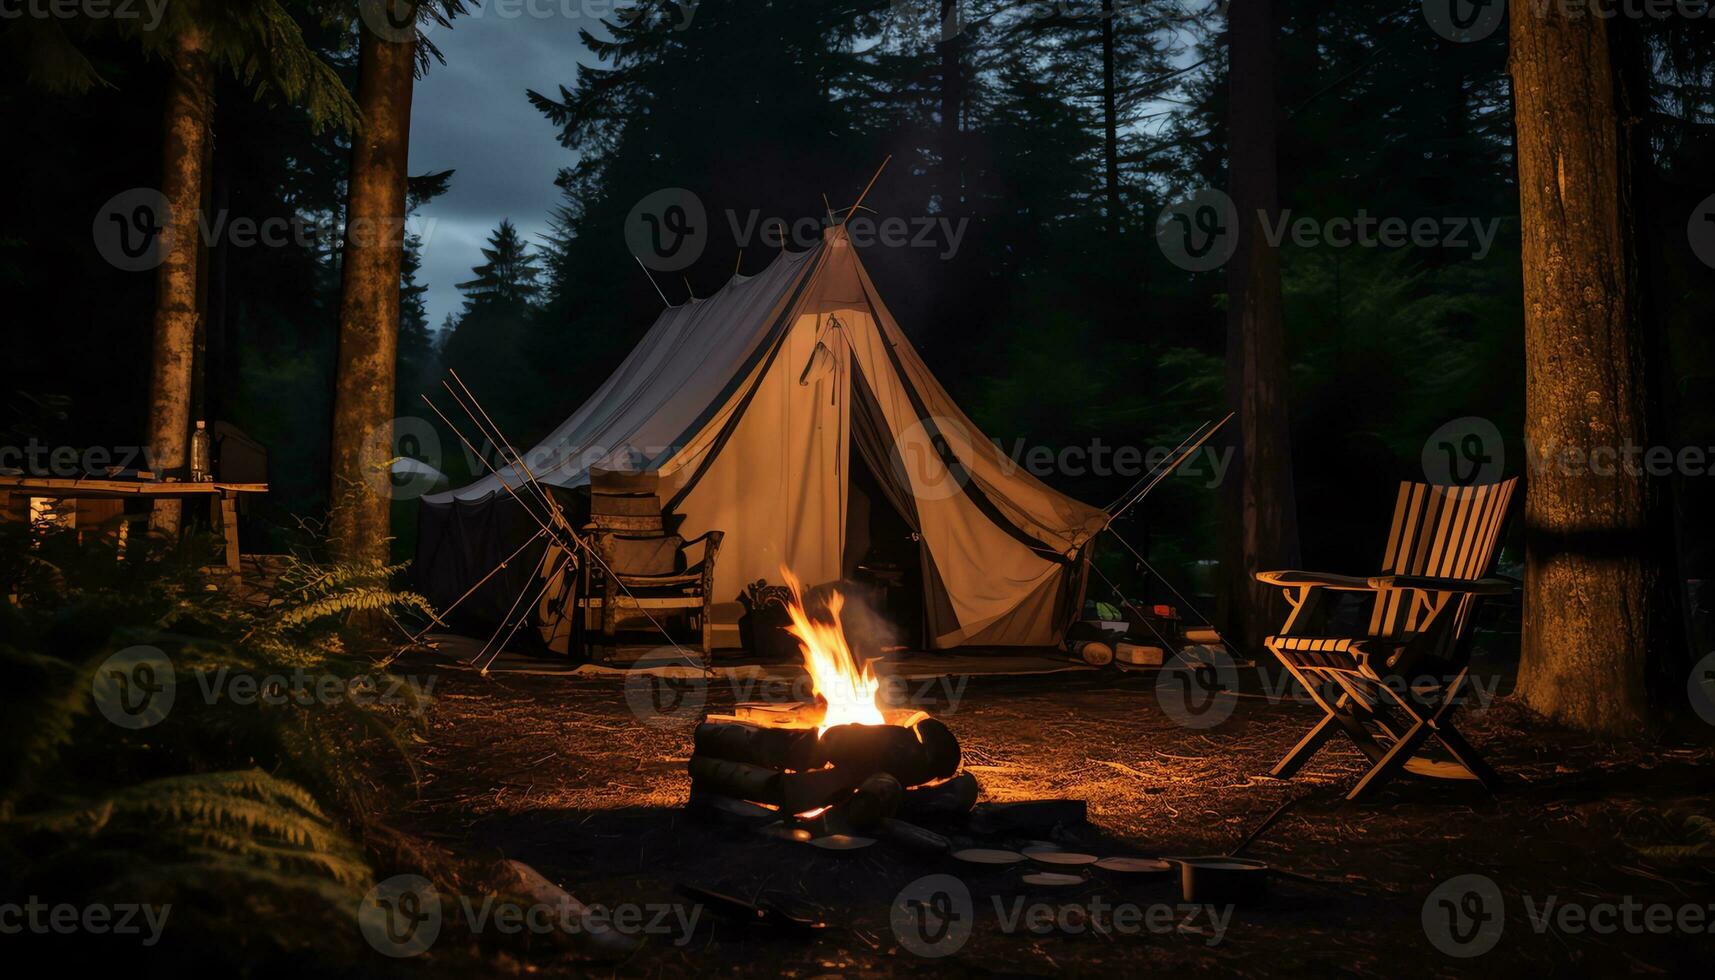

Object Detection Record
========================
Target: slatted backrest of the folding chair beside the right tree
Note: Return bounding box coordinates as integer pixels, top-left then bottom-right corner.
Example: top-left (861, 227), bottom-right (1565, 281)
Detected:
top-left (1370, 477), bottom-right (1518, 654)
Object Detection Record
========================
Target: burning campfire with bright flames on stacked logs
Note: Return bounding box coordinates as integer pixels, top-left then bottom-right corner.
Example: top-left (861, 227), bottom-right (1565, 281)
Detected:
top-left (689, 570), bottom-right (976, 832)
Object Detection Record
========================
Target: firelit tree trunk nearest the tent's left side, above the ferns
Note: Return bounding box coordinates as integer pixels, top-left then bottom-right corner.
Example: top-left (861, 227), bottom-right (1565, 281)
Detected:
top-left (331, 19), bottom-right (415, 561)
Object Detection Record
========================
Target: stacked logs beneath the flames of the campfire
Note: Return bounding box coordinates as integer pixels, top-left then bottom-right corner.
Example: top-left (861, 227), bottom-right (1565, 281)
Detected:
top-left (688, 705), bottom-right (976, 829)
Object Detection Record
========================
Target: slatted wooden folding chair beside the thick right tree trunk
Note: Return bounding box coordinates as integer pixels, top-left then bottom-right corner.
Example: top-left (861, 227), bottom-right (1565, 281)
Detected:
top-left (1257, 479), bottom-right (1518, 800)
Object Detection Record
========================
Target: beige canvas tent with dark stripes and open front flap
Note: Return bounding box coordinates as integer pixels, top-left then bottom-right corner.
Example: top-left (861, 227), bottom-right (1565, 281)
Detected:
top-left (418, 227), bottom-right (1104, 649)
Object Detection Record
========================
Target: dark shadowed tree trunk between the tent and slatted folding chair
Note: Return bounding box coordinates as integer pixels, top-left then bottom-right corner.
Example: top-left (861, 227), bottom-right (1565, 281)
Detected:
top-left (1223, 0), bottom-right (1298, 649)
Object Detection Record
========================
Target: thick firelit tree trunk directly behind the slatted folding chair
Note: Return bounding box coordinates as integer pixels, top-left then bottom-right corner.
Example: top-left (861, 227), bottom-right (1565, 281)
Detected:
top-left (1511, 7), bottom-right (1682, 735)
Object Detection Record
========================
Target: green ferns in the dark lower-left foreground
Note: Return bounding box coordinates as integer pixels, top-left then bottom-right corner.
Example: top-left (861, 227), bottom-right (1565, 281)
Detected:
top-left (0, 523), bottom-right (432, 967)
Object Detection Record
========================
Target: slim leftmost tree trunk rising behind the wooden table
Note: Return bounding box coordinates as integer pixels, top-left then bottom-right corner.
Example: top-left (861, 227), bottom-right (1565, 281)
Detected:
top-left (147, 27), bottom-right (214, 534)
